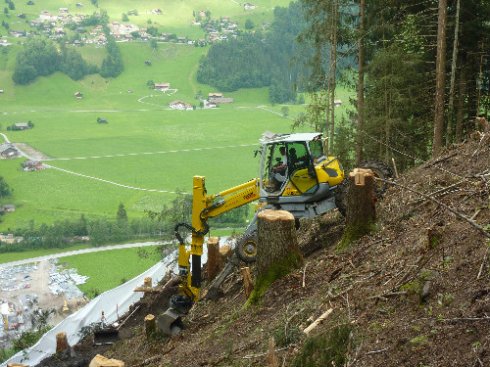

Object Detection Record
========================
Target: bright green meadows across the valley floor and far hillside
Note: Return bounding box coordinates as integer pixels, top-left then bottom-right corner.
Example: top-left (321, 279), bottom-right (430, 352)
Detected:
top-left (0, 0), bottom-right (354, 232)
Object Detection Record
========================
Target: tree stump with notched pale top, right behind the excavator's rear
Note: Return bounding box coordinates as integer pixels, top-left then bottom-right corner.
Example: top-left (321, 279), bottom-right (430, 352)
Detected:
top-left (338, 168), bottom-right (376, 249)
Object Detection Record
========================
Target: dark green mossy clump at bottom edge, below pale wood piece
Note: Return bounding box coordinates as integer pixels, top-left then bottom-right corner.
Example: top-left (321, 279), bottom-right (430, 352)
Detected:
top-left (291, 324), bottom-right (352, 367)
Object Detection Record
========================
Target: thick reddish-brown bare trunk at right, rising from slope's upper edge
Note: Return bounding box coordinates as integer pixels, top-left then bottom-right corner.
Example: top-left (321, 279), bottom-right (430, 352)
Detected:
top-left (432, 0), bottom-right (447, 157)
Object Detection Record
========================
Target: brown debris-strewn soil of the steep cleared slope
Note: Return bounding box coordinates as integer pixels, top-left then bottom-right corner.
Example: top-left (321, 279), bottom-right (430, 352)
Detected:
top-left (40, 136), bottom-right (490, 367)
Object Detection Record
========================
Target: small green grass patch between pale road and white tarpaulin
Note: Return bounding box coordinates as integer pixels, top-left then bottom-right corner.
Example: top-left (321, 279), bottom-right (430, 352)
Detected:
top-left (60, 246), bottom-right (162, 298)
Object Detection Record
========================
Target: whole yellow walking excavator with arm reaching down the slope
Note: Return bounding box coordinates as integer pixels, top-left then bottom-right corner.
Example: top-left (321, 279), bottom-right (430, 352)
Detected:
top-left (157, 133), bottom-right (386, 335)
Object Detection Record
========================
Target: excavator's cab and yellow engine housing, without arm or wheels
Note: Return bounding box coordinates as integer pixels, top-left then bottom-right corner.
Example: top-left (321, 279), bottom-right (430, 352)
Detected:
top-left (260, 133), bottom-right (344, 218)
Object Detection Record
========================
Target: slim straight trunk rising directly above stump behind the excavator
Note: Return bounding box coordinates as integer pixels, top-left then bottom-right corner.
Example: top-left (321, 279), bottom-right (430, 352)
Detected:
top-left (356, 0), bottom-right (366, 165)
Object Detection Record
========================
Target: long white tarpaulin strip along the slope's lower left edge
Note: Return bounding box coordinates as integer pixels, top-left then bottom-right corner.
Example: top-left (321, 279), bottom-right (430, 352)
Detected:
top-left (0, 252), bottom-right (177, 367)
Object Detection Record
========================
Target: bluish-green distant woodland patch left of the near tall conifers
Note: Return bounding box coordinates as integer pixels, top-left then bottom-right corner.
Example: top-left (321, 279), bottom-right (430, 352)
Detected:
top-left (197, 3), bottom-right (311, 103)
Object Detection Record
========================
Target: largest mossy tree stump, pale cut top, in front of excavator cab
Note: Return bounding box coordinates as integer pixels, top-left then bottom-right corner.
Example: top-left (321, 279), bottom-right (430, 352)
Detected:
top-left (250, 209), bottom-right (303, 303)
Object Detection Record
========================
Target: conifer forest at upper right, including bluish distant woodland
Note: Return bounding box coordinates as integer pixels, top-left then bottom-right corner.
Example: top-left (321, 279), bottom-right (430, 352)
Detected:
top-left (197, 0), bottom-right (490, 170)
